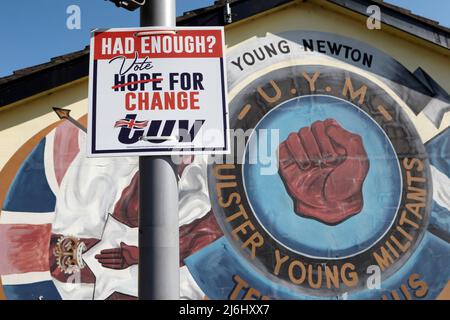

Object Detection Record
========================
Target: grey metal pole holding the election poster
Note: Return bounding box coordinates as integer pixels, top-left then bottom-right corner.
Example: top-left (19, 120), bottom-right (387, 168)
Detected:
top-left (138, 0), bottom-right (180, 300)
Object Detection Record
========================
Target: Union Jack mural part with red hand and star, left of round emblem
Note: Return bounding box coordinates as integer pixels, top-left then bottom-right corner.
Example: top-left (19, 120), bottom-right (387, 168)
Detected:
top-left (0, 122), bottom-right (222, 299)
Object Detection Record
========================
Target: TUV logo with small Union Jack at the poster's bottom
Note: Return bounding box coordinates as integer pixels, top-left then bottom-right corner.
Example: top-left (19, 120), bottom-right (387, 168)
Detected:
top-left (114, 114), bottom-right (205, 144)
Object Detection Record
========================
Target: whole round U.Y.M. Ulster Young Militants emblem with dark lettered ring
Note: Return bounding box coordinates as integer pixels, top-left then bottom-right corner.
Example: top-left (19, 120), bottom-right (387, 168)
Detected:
top-left (208, 65), bottom-right (432, 296)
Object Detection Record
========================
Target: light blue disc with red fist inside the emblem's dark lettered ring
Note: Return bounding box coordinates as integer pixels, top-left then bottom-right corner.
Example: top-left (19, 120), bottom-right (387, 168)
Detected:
top-left (243, 95), bottom-right (402, 259)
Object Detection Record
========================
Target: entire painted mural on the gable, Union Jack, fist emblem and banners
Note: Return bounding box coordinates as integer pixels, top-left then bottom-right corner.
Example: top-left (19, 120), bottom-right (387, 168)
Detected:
top-left (0, 31), bottom-right (450, 299)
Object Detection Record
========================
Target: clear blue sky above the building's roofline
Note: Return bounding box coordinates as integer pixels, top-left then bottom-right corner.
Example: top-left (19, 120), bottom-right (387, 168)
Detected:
top-left (0, 0), bottom-right (450, 77)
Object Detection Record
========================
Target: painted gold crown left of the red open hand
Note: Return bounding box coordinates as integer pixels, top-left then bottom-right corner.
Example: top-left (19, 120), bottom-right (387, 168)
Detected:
top-left (53, 236), bottom-right (86, 274)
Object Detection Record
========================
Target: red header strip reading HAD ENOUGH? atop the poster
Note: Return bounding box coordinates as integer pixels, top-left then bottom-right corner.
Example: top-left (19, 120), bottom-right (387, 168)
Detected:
top-left (94, 29), bottom-right (222, 60)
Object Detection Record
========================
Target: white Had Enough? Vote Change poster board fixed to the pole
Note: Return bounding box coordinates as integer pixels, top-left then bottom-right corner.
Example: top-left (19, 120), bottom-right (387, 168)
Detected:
top-left (87, 27), bottom-right (229, 157)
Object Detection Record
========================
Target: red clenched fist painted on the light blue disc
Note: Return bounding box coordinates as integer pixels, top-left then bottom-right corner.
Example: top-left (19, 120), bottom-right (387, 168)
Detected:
top-left (279, 119), bottom-right (369, 224)
